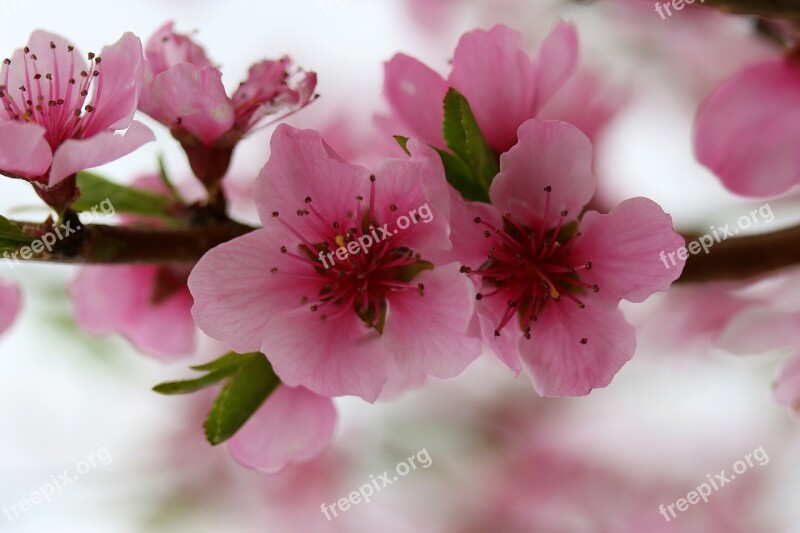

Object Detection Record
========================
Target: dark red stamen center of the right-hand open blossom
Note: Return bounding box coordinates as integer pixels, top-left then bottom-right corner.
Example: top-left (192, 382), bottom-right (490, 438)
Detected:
top-left (461, 186), bottom-right (600, 338)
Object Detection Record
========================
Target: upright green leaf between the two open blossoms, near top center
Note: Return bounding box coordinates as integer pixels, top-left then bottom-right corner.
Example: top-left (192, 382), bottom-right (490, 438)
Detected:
top-left (440, 88), bottom-right (500, 199)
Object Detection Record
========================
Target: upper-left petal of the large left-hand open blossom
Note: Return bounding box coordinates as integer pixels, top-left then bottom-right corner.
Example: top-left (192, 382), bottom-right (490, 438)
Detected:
top-left (253, 124), bottom-right (370, 225)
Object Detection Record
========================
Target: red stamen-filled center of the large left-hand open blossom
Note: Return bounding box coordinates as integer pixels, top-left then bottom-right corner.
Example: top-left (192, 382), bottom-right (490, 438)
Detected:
top-left (271, 176), bottom-right (433, 332)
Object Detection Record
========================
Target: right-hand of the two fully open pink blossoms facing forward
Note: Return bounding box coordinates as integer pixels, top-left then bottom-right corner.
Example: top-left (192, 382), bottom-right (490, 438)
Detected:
top-left (452, 119), bottom-right (683, 396)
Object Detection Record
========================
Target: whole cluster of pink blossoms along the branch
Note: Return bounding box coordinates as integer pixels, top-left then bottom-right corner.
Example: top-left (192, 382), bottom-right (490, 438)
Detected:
top-left (0, 7), bottom-right (800, 472)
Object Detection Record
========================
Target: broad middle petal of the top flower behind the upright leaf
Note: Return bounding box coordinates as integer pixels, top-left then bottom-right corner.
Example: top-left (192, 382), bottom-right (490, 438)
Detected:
top-left (446, 25), bottom-right (535, 153)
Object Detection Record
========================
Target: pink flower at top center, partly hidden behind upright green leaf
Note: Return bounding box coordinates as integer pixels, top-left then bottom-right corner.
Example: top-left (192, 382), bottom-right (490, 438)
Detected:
top-left (384, 22), bottom-right (578, 153)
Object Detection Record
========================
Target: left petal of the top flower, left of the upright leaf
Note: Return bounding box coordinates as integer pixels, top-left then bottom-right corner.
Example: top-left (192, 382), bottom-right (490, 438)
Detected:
top-left (383, 54), bottom-right (447, 148)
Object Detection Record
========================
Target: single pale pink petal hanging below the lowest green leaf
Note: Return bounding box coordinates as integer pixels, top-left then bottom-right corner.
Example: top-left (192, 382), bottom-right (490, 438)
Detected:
top-left (228, 385), bottom-right (336, 474)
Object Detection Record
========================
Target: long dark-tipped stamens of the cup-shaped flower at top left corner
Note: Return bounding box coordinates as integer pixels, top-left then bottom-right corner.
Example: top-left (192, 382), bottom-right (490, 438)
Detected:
top-left (0, 41), bottom-right (103, 150)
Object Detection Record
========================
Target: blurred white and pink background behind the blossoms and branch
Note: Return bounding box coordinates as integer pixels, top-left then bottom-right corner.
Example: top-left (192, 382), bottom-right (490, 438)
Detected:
top-left (0, 0), bottom-right (800, 533)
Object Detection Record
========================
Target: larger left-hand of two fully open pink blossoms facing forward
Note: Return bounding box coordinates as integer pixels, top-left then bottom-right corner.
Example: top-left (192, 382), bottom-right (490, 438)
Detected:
top-left (189, 125), bottom-right (480, 401)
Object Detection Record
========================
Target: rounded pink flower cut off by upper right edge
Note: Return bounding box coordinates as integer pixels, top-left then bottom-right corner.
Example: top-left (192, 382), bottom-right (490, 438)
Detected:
top-left (695, 60), bottom-right (800, 196)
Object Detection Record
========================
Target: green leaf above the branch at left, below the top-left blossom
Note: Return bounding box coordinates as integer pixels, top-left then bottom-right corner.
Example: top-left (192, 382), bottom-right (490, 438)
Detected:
top-left (72, 172), bottom-right (174, 217)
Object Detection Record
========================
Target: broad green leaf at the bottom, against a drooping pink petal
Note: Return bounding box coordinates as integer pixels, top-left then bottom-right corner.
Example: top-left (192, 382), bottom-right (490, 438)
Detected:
top-left (205, 353), bottom-right (280, 446)
